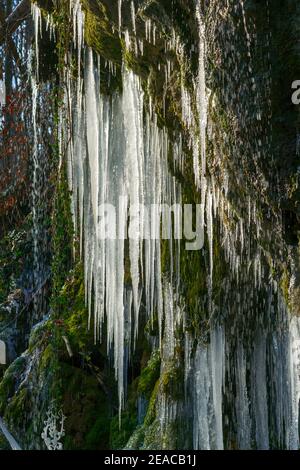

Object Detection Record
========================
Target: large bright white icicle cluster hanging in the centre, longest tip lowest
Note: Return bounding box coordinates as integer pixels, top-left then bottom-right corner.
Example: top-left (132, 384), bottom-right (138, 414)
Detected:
top-left (69, 50), bottom-right (180, 414)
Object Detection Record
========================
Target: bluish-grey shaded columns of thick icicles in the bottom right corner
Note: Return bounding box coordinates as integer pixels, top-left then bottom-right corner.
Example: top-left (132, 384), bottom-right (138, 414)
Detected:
top-left (185, 292), bottom-right (300, 450)
